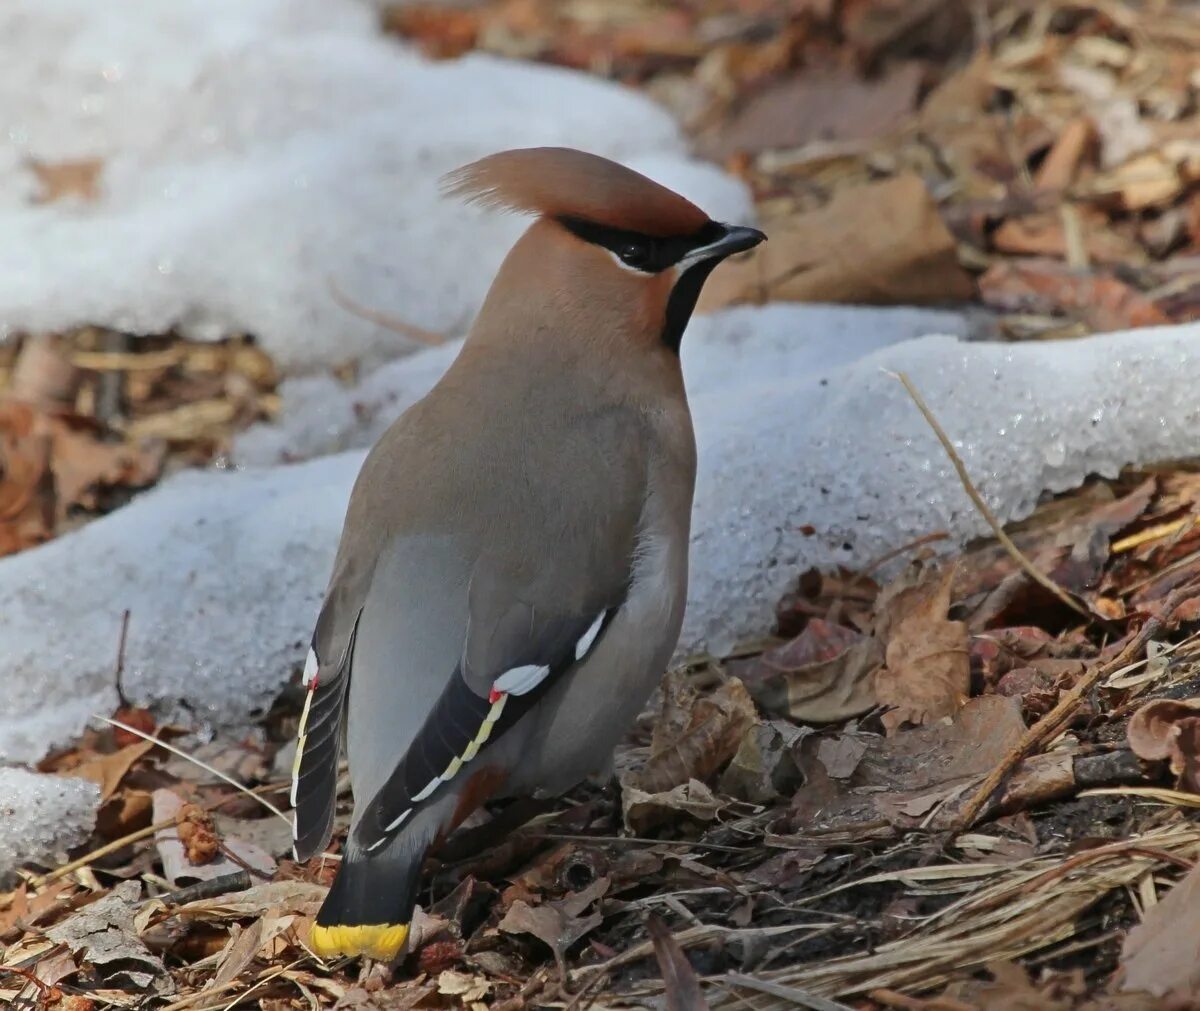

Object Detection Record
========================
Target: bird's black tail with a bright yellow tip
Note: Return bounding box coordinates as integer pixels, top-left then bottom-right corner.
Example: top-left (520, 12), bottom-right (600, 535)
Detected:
top-left (308, 847), bottom-right (422, 962)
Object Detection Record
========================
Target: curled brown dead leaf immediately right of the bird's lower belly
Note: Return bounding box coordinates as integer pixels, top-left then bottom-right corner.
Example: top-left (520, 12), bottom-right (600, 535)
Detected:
top-left (625, 674), bottom-right (757, 794)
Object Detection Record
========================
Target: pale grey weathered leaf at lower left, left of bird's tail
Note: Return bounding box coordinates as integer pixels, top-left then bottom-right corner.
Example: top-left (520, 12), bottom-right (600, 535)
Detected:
top-left (46, 881), bottom-right (174, 995)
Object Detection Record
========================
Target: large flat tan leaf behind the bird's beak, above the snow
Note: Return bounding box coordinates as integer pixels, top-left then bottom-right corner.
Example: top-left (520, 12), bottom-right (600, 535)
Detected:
top-left (701, 174), bottom-right (974, 311)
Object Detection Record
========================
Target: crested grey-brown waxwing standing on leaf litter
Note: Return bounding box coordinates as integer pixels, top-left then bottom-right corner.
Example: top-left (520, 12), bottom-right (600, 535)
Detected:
top-left (292, 148), bottom-right (766, 961)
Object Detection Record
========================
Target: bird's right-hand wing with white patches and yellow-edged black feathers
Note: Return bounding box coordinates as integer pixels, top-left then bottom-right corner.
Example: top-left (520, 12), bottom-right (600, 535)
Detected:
top-left (355, 558), bottom-right (624, 851)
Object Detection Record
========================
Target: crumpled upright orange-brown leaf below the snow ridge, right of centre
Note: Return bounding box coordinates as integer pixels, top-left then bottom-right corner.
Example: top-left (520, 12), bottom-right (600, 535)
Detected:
top-left (875, 566), bottom-right (971, 734)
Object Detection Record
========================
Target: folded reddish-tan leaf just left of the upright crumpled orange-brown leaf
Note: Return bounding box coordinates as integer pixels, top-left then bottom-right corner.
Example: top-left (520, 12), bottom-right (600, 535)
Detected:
top-left (739, 618), bottom-right (883, 723)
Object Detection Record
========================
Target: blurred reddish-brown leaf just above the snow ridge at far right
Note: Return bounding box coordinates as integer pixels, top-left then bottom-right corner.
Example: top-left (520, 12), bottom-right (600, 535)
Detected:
top-left (979, 259), bottom-right (1169, 333)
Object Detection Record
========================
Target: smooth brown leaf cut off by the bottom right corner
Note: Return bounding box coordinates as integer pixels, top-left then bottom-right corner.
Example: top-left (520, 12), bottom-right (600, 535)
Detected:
top-left (1121, 865), bottom-right (1200, 1006)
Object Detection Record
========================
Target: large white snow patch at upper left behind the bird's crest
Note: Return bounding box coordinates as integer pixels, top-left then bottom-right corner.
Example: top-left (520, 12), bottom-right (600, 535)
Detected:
top-left (0, 0), bottom-right (751, 371)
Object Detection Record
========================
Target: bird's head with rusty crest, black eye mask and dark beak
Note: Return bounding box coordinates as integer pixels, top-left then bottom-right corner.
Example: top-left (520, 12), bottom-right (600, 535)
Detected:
top-left (444, 148), bottom-right (767, 352)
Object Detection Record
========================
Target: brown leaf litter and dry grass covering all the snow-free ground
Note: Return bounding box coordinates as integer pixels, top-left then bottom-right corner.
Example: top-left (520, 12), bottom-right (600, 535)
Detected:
top-left (0, 0), bottom-right (1200, 1011)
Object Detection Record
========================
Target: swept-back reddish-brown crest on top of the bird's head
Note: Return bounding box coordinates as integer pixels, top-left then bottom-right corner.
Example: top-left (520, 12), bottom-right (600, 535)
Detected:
top-left (442, 148), bottom-right (708, 238)
